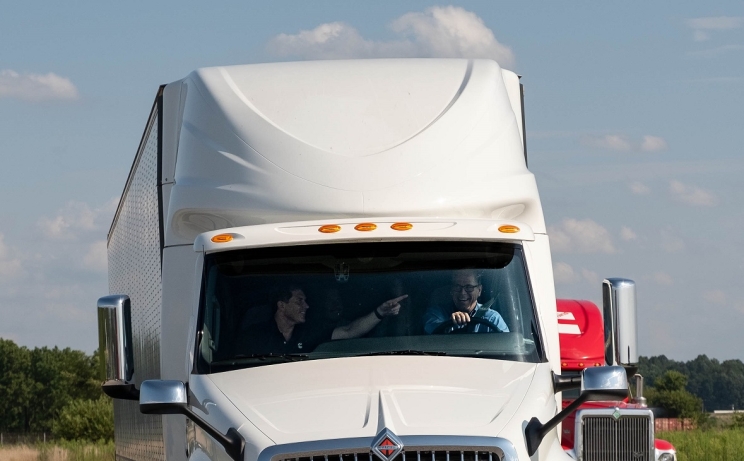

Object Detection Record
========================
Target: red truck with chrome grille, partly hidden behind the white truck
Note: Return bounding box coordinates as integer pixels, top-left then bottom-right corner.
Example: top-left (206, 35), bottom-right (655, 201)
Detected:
top-left (557, 299), bottom-right (677, 461)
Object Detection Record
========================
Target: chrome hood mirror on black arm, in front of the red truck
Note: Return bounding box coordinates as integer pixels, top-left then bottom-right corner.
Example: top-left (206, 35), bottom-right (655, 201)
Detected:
top-left (524, 366), bottom-right (628, 456)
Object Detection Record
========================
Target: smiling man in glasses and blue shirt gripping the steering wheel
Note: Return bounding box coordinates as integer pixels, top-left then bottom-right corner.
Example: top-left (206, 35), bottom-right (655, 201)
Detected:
top-left (424, 269), bottom-right (509, 334)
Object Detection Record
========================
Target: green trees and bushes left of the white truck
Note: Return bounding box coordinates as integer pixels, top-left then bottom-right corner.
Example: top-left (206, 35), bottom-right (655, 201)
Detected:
top-left (0, 338), bottom-right (114, 440)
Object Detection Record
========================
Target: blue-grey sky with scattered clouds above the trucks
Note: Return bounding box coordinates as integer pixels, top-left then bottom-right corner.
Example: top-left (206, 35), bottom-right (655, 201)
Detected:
top-left (0, 0), bottom-right (744, 360)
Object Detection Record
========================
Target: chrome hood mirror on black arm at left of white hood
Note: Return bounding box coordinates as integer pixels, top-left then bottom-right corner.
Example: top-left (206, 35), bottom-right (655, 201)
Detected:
top-left (139, 379), bottom-right (245, 461)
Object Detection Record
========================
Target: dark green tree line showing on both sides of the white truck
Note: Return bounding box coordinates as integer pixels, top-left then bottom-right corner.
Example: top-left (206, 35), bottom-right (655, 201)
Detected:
top-left (0, 338), bottom-right (744, 440)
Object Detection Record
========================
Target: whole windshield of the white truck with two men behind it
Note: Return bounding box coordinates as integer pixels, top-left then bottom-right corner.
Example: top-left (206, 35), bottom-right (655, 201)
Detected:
top-left (196, 242), bottom-right (542, 373)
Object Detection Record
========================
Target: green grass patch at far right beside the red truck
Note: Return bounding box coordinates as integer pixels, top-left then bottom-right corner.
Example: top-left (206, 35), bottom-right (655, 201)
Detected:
top-left (656, 428), bottom-right (744, 461)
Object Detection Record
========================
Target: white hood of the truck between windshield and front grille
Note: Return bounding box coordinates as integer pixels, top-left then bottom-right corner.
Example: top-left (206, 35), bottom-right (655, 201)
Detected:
top-left (209, 356), bottom-right (536, 444)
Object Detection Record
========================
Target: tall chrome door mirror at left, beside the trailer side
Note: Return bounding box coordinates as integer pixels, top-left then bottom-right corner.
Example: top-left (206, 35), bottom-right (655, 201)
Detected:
top-left (98, 295), bottom-right (139, 400)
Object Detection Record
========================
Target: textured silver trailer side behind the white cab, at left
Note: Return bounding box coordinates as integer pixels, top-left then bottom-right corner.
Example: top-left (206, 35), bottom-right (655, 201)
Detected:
top-left (108, 105), bottom-right (165, 461)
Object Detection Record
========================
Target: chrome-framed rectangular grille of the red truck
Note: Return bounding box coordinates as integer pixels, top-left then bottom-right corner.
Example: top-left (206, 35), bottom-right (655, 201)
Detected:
top-left (577, 409), bottom-right (654, 461)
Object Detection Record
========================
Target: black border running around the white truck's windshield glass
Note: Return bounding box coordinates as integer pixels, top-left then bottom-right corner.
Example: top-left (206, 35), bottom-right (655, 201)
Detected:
top-left (192, 239), bottom-right (547, 374)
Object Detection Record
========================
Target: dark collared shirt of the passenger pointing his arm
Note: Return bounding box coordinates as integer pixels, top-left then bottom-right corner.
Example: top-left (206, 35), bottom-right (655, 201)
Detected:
top-left (240, 318), bottom-right (333, 355)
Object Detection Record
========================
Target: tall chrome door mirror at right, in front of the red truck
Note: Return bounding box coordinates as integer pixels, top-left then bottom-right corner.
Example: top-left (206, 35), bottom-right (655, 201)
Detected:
top-left (602, 278), bottom-right (638, 366)
